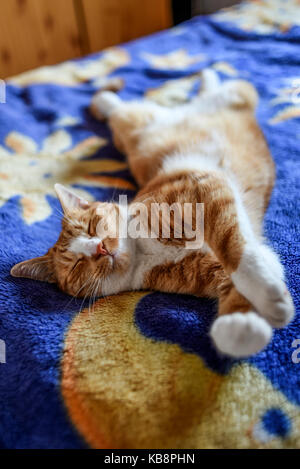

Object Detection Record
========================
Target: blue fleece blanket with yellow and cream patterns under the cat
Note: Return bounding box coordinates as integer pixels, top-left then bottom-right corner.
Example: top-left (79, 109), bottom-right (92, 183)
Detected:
top-left (0, 0), bottom-right (300, 448)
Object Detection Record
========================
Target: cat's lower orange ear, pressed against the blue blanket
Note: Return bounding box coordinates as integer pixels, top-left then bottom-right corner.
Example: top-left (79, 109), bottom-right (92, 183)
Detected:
top-left (10, 254), bottom-right (56, 283)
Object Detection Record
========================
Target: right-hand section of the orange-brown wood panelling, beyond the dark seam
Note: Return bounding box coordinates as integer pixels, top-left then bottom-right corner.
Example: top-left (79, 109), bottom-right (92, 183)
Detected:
top-left (82, 0), bottom-right (171, 52)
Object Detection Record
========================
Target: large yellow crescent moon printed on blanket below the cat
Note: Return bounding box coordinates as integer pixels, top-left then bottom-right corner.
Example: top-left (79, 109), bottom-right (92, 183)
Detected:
top-left (61, 292), bottom-right (300, 449)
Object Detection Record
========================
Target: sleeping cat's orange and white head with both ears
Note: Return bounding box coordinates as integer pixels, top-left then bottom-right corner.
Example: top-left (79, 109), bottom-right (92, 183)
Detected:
top-left (11, 184), bottom-right (133, 297)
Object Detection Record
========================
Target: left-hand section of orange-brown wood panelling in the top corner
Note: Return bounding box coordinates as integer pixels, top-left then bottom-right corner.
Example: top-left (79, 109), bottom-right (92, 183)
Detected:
top-left (0, 0), bottom-right (81, 78)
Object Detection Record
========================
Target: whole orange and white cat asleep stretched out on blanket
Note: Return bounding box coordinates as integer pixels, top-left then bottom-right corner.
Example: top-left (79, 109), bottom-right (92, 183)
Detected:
top-left (11, 69), bottom-right (294, 357)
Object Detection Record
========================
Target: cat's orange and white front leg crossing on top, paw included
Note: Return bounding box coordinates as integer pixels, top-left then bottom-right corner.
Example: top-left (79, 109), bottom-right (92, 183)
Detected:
top-left (199, 173), bottom-right (294, 327)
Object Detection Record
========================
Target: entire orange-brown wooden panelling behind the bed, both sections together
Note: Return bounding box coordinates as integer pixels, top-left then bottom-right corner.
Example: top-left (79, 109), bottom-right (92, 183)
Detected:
top-left (0, 0), bottom-right (171, 79)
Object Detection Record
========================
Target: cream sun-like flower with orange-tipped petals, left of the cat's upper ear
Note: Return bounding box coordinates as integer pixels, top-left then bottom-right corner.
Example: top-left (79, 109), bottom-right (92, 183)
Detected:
top-left (0, 130), bottom-right (134, 224)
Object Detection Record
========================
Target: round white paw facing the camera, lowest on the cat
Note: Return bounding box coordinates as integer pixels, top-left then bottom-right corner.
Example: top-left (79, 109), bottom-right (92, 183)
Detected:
top-left (210, 312), bottom-right (272, 358)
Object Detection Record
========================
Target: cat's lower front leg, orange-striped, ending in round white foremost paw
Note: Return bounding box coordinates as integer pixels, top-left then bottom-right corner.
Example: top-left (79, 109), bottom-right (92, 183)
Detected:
top-left (142, 241), bottom-right (272, 357)
